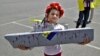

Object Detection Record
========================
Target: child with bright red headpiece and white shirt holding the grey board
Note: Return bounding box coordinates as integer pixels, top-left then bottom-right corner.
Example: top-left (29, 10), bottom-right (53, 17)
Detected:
top-left (18, 2), bottom-right (90, 56)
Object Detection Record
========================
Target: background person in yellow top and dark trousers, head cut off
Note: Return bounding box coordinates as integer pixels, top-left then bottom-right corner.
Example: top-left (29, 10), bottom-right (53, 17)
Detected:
top-left (76, 0), bottom-right (94, 28)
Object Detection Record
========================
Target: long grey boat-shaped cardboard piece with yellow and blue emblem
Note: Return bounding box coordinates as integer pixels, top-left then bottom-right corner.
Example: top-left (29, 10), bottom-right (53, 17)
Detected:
top-left (5, 28), bottom-right (94, 48)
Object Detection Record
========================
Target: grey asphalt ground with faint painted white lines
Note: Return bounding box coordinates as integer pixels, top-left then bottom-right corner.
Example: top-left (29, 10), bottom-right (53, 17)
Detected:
top-left (0, 0), bottom-right (100, 56)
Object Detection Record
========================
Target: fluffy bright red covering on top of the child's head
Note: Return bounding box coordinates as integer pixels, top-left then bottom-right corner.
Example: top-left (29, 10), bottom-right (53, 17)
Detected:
top-left (46, 2), bottom-right (64, 17)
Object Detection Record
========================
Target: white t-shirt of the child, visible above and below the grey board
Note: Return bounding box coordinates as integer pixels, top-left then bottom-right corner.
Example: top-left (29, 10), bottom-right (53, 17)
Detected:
top-left (44, 24), bottom-right (65, 55)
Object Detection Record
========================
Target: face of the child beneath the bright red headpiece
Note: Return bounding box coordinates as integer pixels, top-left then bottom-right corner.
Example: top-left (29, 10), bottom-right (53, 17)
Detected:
top-left (47, 9), bottom-right (60, 23)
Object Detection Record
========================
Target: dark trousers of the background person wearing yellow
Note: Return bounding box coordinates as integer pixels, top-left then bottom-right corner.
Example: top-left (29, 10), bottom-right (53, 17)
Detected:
top-left (76, 7), bottom-right (90, 28)
